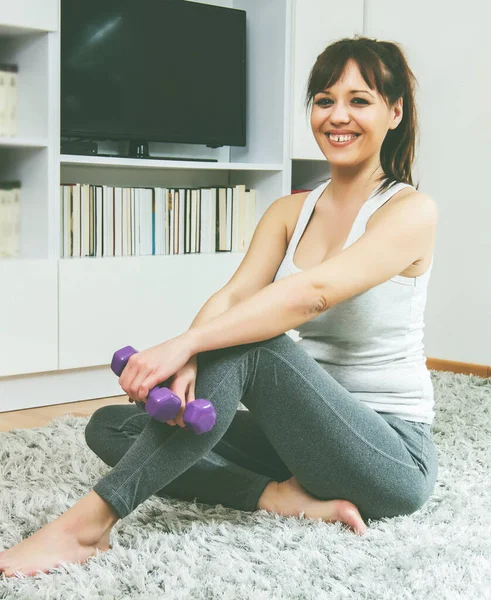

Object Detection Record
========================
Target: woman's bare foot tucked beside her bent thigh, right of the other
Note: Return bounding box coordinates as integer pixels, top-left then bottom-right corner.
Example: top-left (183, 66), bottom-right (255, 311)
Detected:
top-left (258, 477), bottom-right (367, 535)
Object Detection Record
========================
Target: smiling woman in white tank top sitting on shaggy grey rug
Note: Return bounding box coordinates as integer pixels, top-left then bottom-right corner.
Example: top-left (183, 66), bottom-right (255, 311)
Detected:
top-left (0, 36), bottom-right (437, 576)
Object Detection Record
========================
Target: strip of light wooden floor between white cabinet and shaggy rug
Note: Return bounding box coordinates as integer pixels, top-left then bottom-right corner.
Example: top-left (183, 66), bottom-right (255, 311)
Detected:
top-left (0, 396), bottom-right (128, 431)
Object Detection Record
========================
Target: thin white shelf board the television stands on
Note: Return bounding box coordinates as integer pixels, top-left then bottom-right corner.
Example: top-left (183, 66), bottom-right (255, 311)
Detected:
top-left (60, 154), bottom-right (284, 171)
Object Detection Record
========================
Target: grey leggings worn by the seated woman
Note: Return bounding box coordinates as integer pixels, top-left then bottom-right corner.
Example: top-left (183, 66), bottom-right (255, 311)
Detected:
top-left (85, 334), bottom-right (438, 521)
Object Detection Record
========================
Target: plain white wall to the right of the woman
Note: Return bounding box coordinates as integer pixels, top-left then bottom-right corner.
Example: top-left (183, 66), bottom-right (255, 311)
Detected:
top-left (364, 0), bottom-right (491, 365)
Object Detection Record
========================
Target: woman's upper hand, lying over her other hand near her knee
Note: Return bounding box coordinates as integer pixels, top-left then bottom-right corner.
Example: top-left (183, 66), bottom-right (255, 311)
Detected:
top-left (119, 335), bottom-right (193, 401)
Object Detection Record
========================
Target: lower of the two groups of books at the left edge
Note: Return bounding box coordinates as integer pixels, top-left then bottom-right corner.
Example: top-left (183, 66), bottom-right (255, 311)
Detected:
top-left (0, 181), bottom-right (21, 258)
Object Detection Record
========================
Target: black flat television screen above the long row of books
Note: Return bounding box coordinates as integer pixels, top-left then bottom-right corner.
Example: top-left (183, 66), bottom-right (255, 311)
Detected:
top-left (61, 0), bottom-right (246, 147)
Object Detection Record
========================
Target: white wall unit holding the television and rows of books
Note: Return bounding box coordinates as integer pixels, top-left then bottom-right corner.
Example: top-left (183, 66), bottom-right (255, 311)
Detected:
top-left (0, 0), bottom-right (363, 412)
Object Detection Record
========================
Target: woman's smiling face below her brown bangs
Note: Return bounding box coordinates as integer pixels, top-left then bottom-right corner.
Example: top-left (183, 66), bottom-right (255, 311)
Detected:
top-left (310, 61), bottom-right (402, 166)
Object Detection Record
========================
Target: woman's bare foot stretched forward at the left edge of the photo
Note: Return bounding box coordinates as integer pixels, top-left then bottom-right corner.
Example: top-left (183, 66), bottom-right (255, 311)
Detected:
top-left (0, 491), bottom-right (118, 577)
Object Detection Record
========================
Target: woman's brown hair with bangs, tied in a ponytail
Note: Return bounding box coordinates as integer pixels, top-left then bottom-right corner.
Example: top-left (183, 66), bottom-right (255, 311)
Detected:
top-left (305, 35), bottom-right (419, 191)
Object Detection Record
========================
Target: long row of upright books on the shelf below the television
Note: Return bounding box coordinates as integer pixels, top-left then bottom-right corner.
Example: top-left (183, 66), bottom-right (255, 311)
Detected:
top-left (60, 183), bottom-right (256, 257)
